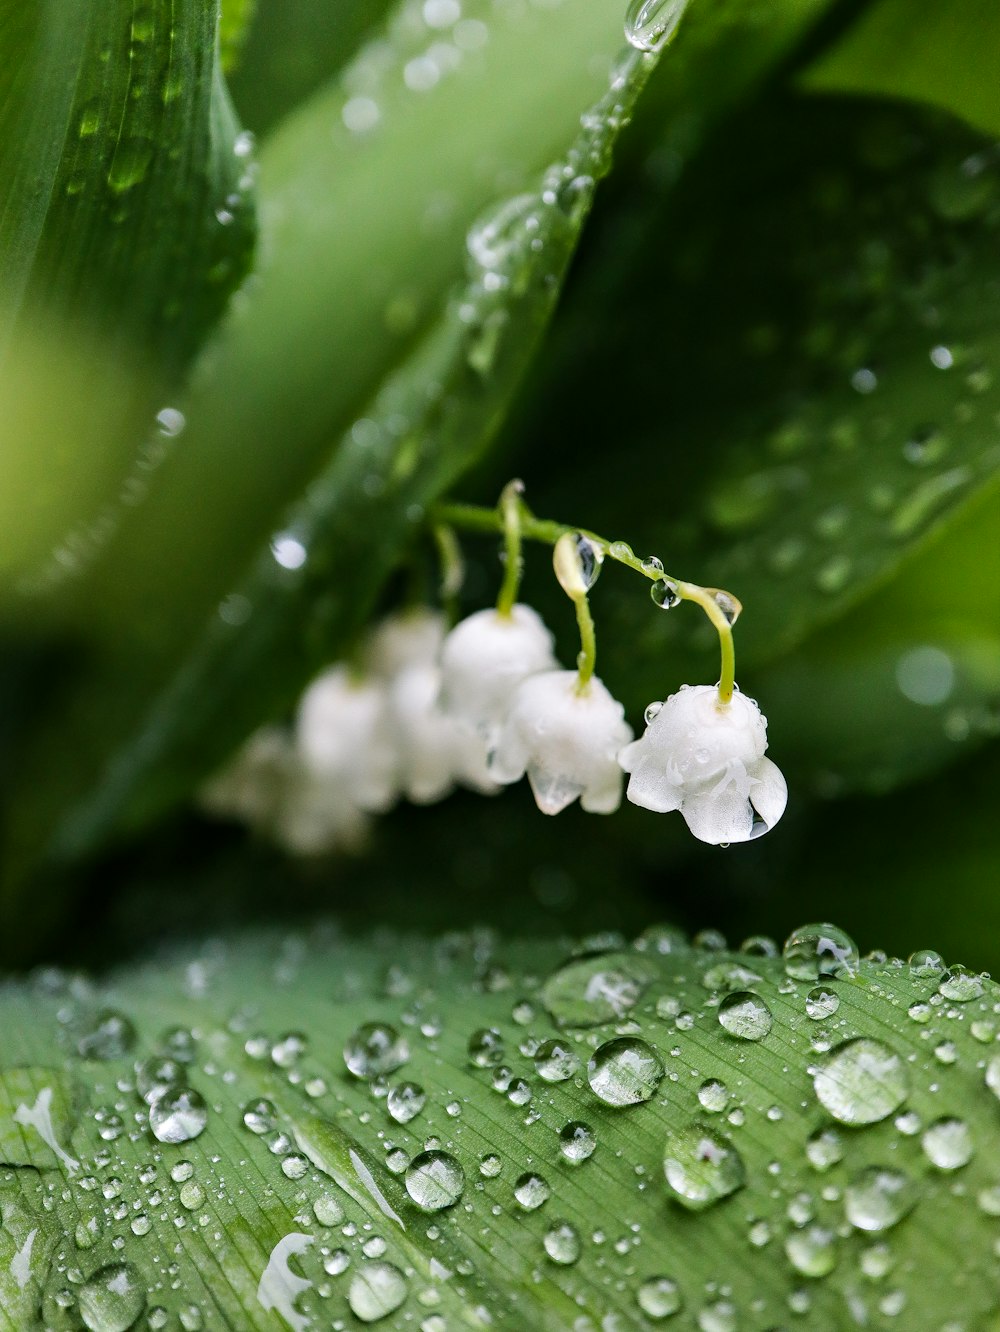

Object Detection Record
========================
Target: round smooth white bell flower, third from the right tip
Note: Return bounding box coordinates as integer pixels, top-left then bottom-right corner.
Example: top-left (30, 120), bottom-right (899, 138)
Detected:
top-left (441, 603), bottom-right (558, 749)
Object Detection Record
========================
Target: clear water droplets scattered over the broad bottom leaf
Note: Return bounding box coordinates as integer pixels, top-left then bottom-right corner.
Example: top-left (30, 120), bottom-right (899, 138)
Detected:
top-left (21, 924), bottom-right (1000, 1332)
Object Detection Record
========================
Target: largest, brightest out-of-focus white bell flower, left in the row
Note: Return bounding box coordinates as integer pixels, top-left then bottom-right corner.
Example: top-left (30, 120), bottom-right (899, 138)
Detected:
top-left (296, 666), bottom-right (398, 814)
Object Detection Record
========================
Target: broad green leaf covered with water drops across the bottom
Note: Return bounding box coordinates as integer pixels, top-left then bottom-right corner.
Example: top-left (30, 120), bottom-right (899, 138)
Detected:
top-left (0, 926), bottom-right (1000, 1332)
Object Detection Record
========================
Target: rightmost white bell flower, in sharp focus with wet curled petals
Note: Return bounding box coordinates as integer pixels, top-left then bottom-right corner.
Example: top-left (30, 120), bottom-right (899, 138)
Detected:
top-left (619, 685), bottom-right (788, 846)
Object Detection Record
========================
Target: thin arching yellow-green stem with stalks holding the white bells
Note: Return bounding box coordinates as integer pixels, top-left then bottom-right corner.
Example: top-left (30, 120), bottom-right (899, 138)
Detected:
top-left (433, 482), bottom-right (736, 703)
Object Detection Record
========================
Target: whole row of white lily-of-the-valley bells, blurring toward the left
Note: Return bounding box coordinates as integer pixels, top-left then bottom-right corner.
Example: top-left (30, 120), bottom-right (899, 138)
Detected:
top-left (202, 603), bottom-right (787, 854)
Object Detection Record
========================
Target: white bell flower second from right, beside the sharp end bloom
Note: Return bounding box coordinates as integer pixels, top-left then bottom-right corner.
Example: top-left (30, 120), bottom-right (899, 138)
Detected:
top-left (490, 670), bottom-right (632, 814)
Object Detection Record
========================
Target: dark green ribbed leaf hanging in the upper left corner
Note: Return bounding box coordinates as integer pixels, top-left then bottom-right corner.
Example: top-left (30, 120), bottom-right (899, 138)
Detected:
top-left (0, 0), bottom-right (253, 583)
